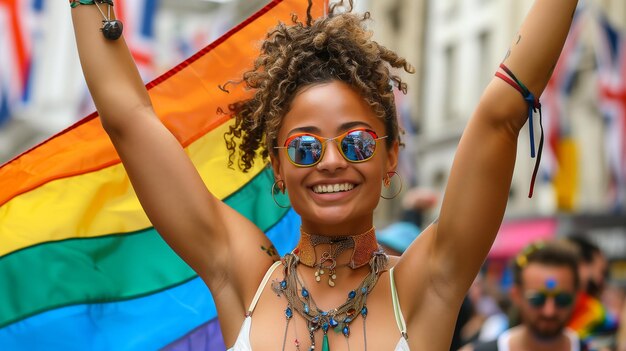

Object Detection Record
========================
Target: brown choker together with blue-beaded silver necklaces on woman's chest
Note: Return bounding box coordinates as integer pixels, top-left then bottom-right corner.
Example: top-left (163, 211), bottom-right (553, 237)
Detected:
top-left (272, 228), bottom-right (387, 351)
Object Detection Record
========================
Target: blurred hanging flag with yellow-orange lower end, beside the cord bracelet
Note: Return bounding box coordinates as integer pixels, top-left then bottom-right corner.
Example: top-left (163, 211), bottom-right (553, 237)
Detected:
top-left (541, 10), bottom-right (585, 211)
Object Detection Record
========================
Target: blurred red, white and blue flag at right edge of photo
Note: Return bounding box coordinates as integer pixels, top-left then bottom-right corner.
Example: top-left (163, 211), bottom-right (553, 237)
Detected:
top-left (595, 15), bottom-right (626, 211)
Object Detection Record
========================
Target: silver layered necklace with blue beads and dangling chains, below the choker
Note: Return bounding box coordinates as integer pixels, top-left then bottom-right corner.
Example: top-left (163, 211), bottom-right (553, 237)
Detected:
top-left (272, 249), bottom-right (387, 351)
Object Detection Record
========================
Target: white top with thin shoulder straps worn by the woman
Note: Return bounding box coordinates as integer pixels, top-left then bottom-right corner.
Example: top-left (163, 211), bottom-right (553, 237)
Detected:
top-left (228, 261), bottom-right (410, 351)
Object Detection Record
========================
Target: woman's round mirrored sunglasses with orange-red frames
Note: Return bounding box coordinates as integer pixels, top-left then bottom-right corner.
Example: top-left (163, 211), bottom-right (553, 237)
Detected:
top-left (275, 128), bottom-right (387, 167)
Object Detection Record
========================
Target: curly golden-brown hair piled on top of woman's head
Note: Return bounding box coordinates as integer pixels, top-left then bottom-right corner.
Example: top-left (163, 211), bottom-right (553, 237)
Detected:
top-left (224, 0), bottom-right (415, 172)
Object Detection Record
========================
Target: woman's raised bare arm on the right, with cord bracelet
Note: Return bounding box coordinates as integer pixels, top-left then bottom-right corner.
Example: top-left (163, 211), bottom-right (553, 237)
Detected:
top-left (398, 0), bottom-right (577, 304)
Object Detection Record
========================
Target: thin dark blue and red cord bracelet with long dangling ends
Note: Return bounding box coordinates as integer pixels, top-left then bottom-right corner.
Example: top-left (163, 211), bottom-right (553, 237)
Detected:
top-left (496, 63), bottom-right (543, 197)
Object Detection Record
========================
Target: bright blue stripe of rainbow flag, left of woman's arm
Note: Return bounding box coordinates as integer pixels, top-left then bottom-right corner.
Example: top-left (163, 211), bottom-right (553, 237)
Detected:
top-left (0, 278), bottom-right (217, 351)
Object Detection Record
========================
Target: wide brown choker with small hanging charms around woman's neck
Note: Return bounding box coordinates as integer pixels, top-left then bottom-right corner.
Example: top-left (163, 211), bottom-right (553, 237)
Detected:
top-left (293, 227), bottom-right (378, 287)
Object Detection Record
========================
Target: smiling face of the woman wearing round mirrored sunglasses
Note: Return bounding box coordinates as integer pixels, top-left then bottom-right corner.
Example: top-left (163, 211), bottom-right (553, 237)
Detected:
top-left (272, 80), bottom-right (398, 235)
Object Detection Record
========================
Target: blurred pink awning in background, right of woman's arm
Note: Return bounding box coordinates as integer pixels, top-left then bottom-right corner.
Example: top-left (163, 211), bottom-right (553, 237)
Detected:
top-left (487, 218), bottom-right (558, 259)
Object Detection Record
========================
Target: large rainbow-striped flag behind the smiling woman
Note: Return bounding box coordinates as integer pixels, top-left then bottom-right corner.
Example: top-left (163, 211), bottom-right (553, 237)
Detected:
top-left (0, 0), bottom-right (326, 350)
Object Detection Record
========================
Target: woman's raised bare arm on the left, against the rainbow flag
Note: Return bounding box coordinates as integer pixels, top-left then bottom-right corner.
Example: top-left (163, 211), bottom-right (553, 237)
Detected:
top-left (71, 4), bottom-right (271, 300)
